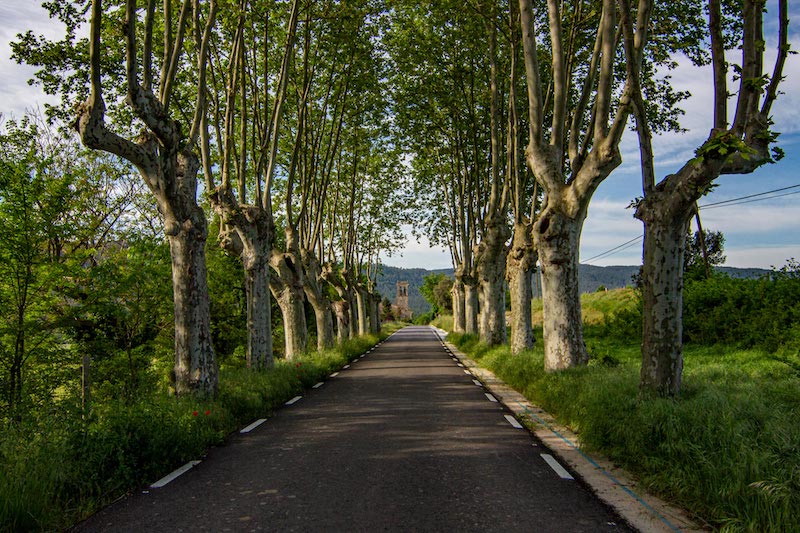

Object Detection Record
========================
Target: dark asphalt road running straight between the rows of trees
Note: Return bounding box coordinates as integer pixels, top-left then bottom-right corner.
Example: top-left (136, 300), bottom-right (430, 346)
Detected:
top-left (77, 327), bottom-right (630, 533)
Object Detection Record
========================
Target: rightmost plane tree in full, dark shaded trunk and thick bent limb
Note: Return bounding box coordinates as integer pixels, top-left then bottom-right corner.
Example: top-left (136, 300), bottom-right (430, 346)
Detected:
top-left (625, 0), bottom-right (789, 396)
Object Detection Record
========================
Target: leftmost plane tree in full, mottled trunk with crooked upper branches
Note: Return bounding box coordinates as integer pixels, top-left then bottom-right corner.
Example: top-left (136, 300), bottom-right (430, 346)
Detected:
top-left (67, 0), bottom-right (217, 396)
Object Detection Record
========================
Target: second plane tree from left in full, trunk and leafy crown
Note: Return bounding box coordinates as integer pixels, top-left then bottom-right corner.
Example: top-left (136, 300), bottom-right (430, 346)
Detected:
top-left (200, 0), bottom-right (300, 369)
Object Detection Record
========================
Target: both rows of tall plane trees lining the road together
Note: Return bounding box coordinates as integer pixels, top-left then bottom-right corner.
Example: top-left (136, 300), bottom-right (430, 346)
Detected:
top-left (14, 0), bottom-right (789, 402)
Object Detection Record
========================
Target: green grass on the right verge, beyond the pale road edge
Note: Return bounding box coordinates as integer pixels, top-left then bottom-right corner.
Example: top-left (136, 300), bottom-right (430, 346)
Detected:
top-left (448, 291), bottom-right (800, 531)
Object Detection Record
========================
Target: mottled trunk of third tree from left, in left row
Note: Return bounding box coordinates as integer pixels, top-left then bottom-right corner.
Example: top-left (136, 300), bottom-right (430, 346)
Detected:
top-left (270, 252), bottom-right (308, 359)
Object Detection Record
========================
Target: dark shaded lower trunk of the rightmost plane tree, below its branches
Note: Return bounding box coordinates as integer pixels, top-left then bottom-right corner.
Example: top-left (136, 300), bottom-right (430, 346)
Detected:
top-left (636, 197), bottom-right (691, 397)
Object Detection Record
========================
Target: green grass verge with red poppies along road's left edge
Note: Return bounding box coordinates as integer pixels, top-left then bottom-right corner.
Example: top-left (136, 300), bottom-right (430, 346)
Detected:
top-left (0, 324), bottom-right (400, 531)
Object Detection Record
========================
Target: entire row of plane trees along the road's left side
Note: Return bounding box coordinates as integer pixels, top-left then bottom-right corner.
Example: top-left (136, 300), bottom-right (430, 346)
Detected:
top-left (14, 0), bottom-right (410, 402)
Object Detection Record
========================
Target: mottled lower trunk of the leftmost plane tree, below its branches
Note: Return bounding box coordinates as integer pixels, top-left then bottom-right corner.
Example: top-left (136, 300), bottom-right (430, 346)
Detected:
top-left (168, 220), bottom-right (217, 397)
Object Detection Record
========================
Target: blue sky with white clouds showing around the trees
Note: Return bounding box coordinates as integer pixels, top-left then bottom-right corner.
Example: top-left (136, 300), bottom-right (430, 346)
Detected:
top-left (0, 0), bottom-right (800, 269)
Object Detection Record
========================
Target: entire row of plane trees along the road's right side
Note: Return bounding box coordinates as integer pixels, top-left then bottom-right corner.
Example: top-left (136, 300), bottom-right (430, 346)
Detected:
top-left (389, 0), bottom-right (789, 395)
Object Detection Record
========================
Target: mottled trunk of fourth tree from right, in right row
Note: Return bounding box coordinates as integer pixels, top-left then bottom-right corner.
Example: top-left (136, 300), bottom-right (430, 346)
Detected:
top-left (475, 221), bottom-right (510, 346)
